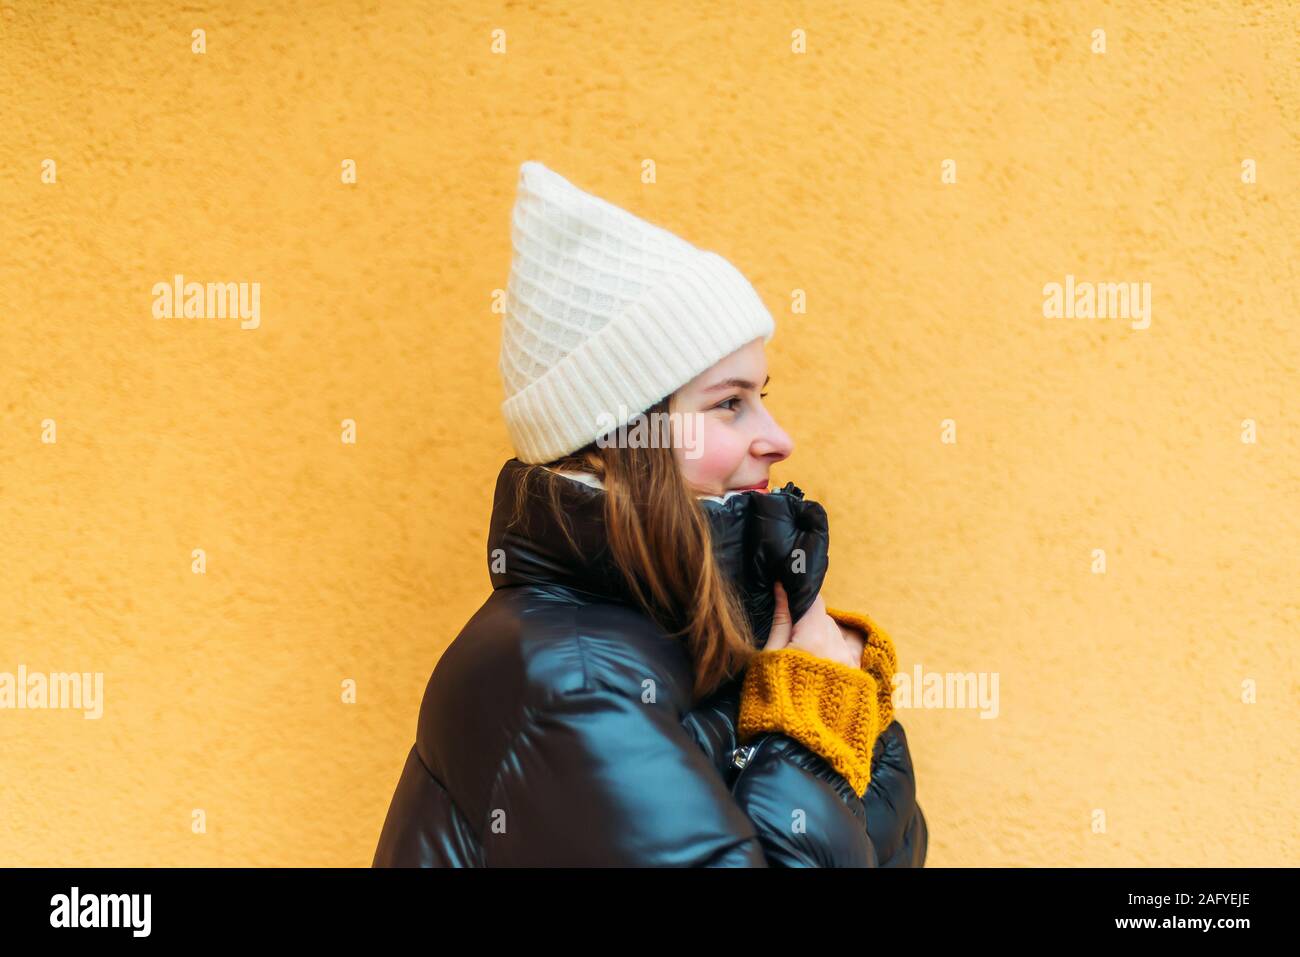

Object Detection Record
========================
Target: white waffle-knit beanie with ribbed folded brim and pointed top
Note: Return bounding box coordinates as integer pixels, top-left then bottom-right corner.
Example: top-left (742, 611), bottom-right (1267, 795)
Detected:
top-left (499, 160), bottom-right (775, 463)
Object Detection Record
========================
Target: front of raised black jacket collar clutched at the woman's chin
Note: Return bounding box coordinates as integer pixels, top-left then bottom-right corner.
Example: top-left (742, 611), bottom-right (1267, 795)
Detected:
top-left (699, 482), bottom-right (831, 648)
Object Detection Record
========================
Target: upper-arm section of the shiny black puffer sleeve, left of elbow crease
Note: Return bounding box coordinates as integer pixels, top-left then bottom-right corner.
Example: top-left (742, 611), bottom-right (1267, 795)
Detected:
top-left (482, 687), bottom-right (774, 867)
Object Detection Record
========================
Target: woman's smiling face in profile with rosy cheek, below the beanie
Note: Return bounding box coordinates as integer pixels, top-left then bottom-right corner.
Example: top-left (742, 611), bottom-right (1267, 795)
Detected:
top-left (668, 339), bottom-right (794, 495)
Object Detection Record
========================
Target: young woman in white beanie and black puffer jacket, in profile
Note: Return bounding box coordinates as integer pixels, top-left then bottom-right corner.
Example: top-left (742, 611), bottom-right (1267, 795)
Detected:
top-left (373, 163), bottom-right (928, 867)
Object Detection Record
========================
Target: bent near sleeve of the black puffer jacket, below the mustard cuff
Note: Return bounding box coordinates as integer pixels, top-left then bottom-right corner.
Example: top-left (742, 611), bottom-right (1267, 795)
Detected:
top-left (482, 666), bottom-right (894, 867)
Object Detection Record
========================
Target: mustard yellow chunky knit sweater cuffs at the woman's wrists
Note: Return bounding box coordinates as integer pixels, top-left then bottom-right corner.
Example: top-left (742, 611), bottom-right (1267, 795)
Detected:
top-left (736, 607), bottom-right (898, 797)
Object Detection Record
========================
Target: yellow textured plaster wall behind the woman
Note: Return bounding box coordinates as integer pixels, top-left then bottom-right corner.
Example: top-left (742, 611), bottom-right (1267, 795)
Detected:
top-left (0, 0), bottom-right (1300, 866)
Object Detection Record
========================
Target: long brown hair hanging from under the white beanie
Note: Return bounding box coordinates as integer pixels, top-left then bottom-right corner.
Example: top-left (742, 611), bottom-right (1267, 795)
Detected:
top-left (514, 398), bottom-right (757, 702)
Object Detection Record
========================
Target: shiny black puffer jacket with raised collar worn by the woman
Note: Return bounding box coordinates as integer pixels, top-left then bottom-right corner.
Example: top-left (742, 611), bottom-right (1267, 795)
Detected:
top-left (373, 459), bottom-right (927, 867)
